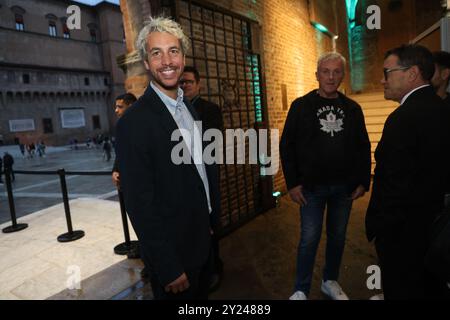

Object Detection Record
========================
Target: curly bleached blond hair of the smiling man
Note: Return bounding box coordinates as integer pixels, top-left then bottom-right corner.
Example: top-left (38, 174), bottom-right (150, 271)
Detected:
top-left (136, 16), bottom-right (190, 60)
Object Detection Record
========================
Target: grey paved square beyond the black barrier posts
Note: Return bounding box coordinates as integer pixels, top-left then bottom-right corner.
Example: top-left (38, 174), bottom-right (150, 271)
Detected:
top-left (0, 146), bottom-right (117, 224)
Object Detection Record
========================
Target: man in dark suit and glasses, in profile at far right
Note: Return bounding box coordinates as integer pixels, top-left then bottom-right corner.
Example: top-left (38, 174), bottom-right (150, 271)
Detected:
top-left (366, 45), bottom-right (450, 299)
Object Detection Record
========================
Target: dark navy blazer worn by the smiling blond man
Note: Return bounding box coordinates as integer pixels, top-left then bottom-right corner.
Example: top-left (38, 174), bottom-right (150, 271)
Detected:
top-left (117, 86), bottom-right (220, 286)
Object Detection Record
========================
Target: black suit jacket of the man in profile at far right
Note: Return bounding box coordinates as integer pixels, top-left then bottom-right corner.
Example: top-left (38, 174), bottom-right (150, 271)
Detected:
top-left (366, 86), bottom-right (450, 241)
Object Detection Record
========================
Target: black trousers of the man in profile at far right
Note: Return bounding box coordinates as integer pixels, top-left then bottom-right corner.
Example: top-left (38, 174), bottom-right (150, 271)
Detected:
top-left (375, 231), bottom-right (450, 300)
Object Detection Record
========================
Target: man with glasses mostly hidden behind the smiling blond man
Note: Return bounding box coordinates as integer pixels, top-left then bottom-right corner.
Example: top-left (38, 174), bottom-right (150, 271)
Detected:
top-left (180, 66), bottom-right (223, 292)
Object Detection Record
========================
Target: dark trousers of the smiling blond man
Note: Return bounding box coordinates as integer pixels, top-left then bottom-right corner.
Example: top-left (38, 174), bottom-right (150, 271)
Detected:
top-left (150, 250), bottom-right (214, 300)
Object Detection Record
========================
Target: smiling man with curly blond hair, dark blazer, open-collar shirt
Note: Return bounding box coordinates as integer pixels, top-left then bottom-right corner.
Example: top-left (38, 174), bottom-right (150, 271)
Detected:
top-left (117, 17), bottom-right (220, 299)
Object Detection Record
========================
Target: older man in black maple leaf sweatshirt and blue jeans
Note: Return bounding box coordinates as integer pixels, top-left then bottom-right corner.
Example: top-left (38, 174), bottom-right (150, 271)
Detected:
top-left (280, 52), bottom-right (371, 300)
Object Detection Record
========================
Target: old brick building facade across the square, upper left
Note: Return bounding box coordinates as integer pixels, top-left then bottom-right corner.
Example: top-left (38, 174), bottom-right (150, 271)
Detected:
top-left (0, 0), bottom-right (125, 145)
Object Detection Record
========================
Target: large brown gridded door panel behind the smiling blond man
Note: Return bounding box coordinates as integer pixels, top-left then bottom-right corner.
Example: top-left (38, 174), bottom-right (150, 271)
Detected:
top-left (175, 1), bottom-right (264, 234)
